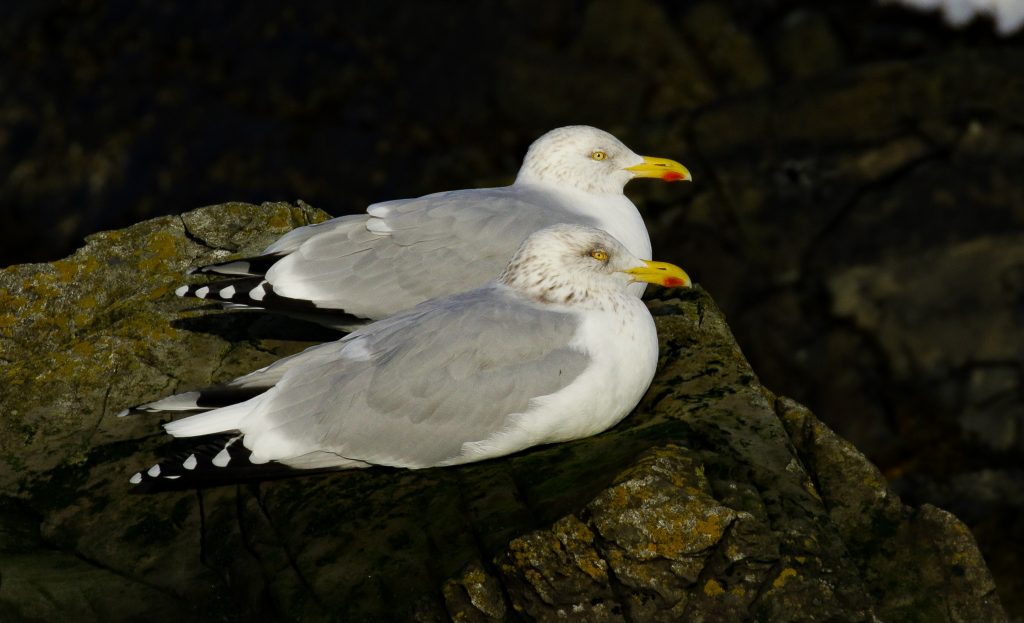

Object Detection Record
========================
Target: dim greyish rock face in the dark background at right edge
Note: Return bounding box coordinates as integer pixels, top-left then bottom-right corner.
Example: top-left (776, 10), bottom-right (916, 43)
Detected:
top-left (828, 234), bottom-right (1024, 451)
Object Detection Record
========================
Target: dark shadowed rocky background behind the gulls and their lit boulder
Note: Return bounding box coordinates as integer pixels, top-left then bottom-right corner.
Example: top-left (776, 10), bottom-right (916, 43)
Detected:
top-left (0, 0), bottom-right (1024, 617)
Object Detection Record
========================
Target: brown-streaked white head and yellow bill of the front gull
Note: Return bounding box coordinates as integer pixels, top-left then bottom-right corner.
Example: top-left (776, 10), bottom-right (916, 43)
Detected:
top-left (499, 224), bottom-right (690, 306)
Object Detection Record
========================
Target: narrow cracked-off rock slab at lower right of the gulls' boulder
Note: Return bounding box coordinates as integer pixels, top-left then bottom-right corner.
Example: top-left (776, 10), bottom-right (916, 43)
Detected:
top-left (777, 399), bottom-right (996, 621)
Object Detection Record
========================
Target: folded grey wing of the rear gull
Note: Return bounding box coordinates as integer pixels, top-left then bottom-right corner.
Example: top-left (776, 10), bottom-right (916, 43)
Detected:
top-left (266, 186), bottom-right (596, 319)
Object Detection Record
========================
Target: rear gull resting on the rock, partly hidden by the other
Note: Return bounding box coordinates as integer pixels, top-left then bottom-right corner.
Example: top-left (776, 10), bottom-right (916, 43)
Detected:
top-left (176, 125), bottom-right (691, 331)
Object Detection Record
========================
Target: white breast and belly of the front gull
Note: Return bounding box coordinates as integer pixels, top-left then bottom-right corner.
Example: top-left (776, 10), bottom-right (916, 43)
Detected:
top-left (445, 296), bottom-right (657, 464)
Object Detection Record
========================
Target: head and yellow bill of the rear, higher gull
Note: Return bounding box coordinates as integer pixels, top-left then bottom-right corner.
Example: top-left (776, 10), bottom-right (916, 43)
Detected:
top-left (515, 125), bottom-right (690, 195)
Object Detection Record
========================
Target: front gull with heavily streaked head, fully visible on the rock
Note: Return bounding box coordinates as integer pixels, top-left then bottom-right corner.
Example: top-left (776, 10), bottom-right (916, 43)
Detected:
top-left (121, 224), bottom-right (691, 492)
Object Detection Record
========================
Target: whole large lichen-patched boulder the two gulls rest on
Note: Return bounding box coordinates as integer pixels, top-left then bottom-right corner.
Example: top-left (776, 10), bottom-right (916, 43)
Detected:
top-left (0, 204), bottom-right (1006, 622)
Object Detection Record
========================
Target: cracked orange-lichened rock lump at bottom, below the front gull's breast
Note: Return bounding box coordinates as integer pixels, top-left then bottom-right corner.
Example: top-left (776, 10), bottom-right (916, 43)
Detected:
top-left (499, 445), bottom-right (736, 621)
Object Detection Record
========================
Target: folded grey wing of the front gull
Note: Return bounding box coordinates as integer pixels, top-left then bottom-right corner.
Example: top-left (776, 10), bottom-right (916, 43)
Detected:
top-left (243, 287), bottom-right (590, 467)
